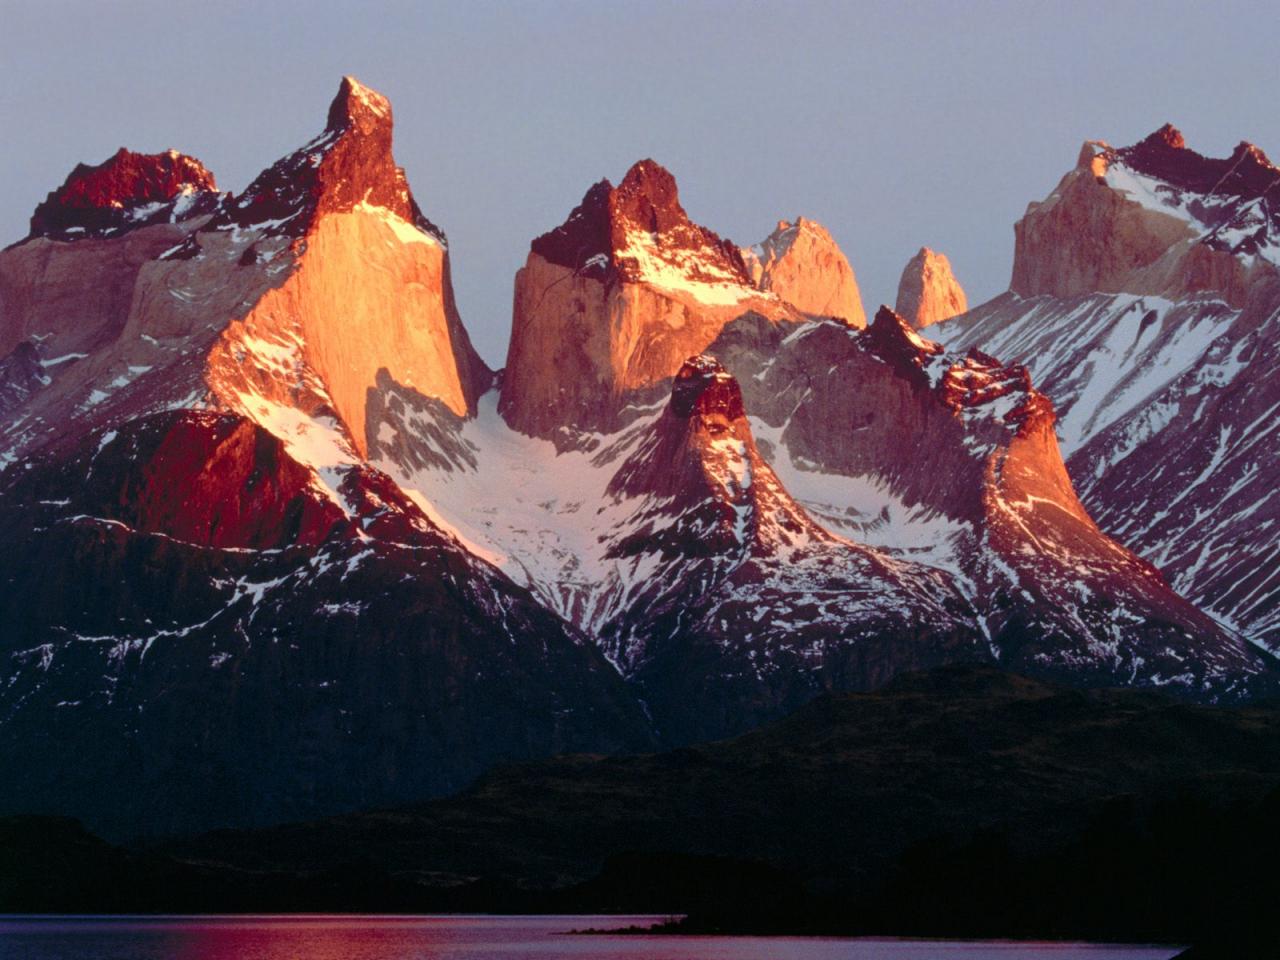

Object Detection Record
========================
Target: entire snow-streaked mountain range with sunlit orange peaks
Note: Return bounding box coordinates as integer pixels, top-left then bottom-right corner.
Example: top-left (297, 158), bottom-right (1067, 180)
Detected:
top-left (0, 77), bottom-right (1280, 837)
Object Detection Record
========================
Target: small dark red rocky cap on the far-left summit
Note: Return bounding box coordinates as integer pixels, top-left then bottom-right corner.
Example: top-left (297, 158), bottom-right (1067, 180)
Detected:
top-left (28, 147), bottom-right (221, 241)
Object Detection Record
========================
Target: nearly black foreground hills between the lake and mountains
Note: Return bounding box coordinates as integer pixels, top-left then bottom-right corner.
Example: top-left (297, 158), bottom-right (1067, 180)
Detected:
top-left (0, 667), bottom-right (1280, 942)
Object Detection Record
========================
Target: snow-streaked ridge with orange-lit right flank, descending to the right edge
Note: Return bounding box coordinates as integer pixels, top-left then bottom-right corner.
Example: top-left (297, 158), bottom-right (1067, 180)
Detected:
top-left (712, 308), bottom-right (1274, 698)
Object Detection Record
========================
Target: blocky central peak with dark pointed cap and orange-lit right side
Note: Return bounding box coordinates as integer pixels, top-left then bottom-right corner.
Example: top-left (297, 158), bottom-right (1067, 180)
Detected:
top-left (499, 160), bottom-right (801, 439)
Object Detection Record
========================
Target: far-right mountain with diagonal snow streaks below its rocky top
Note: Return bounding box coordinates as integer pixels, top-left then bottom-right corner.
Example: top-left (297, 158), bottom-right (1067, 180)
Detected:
top-left (934, 127), bottom-right (1280, 648)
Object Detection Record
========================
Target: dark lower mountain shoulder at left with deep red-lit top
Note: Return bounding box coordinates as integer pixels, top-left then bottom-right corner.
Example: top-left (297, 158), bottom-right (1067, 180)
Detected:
top-left (0, 413), bottom-right (650, 836)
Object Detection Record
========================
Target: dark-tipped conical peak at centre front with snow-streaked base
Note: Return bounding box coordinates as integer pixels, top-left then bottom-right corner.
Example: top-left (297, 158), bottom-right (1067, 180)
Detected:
top-left (598, 356), bottom-right (991, 742)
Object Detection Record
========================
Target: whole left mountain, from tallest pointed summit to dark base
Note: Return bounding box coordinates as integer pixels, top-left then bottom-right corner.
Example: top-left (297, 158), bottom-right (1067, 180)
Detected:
top-left (0, 78), bottom-right (652, 836)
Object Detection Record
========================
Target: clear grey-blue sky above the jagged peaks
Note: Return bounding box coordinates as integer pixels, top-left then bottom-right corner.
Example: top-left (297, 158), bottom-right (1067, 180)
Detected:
top-left (0, 0), bottom-right (1280, 365)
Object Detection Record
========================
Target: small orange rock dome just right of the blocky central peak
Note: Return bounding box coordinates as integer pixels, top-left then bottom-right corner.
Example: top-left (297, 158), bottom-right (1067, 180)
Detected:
top-left (742, 216), bottom-right (867, 326)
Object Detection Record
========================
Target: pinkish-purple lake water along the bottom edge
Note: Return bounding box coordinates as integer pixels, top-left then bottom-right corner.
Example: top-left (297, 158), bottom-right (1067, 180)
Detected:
top-left (0, 916), bottom-right (1178, 960)
